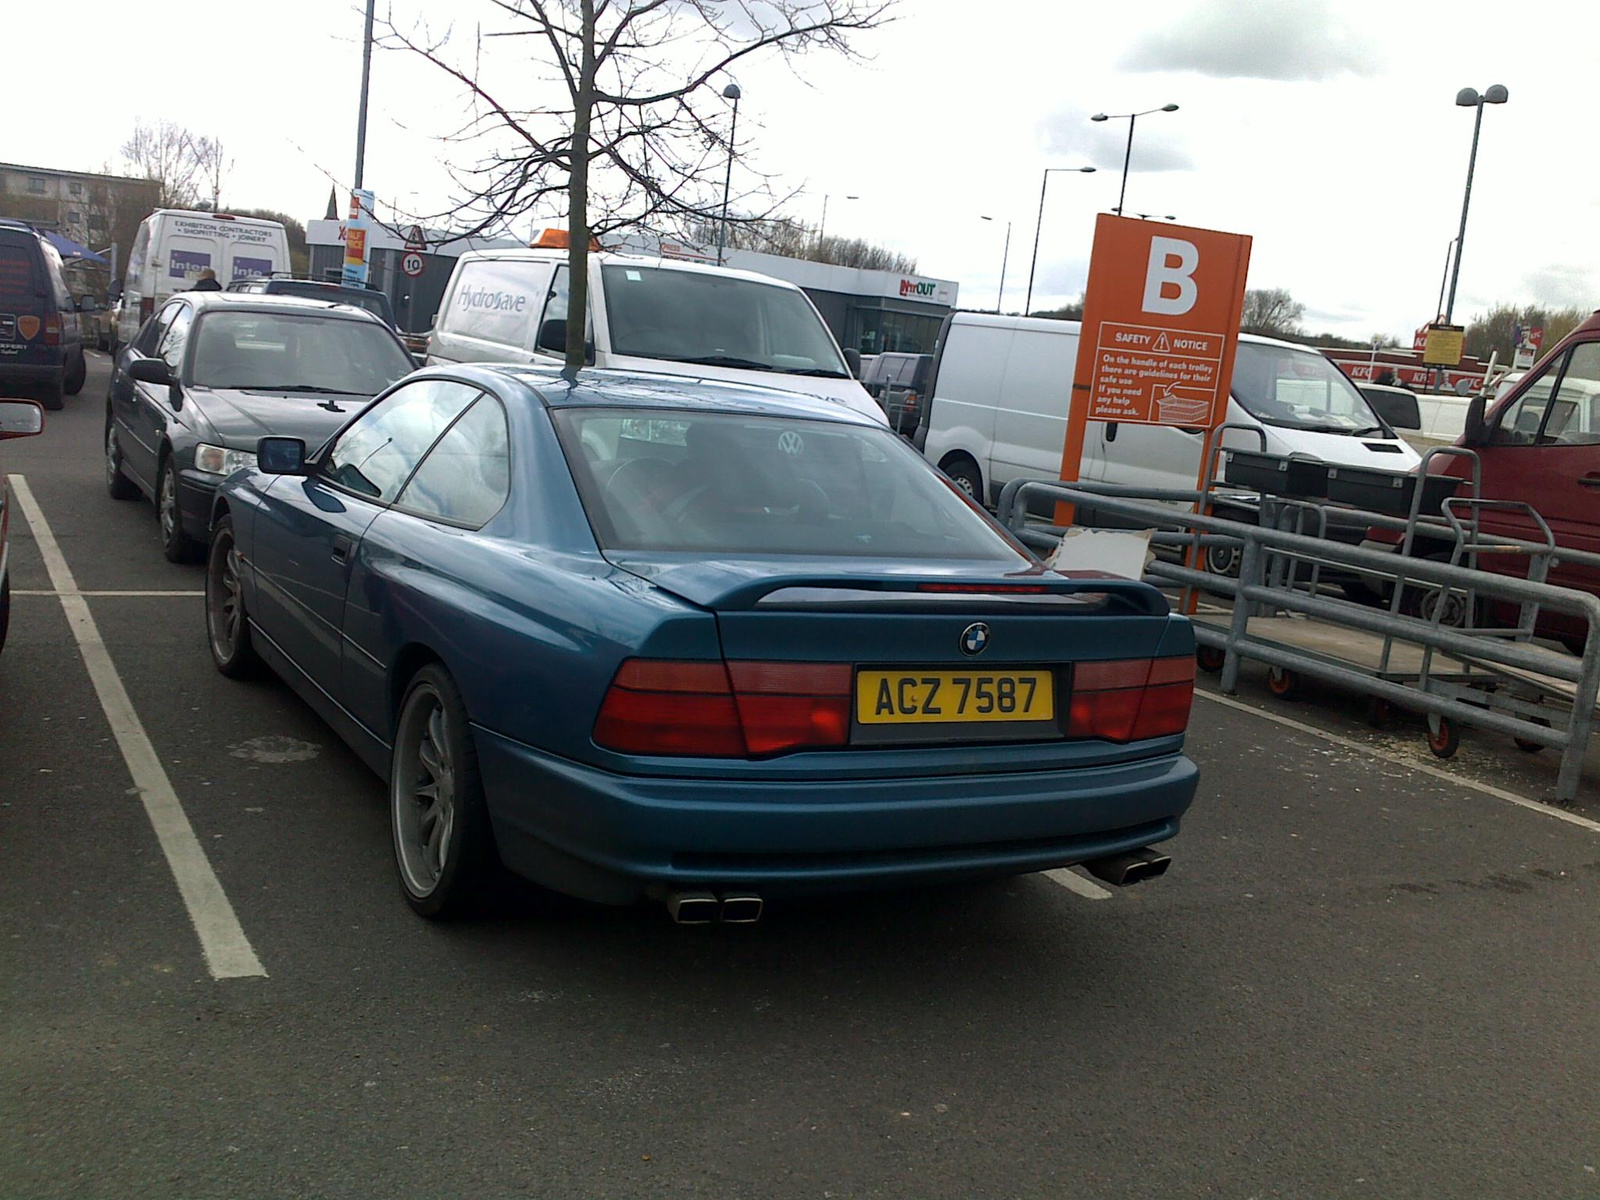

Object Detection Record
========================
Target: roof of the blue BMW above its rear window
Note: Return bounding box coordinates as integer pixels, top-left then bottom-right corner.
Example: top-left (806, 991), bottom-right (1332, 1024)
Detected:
top-left (444, 363), bottom-right (883, 429)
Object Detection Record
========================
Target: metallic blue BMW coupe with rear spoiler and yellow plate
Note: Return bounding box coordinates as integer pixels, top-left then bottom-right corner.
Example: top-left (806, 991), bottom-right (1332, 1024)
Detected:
top-left (206, 366), bottom-right (1197, 920)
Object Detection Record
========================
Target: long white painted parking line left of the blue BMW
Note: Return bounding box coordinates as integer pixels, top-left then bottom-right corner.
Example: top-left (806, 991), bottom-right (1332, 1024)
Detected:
top-left (11, 475), bottom-right (266, 979)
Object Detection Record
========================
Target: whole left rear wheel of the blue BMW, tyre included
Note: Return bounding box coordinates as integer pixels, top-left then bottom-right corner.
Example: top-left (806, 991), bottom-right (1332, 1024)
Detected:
top-left (389, 662), bottom-right (499, 917)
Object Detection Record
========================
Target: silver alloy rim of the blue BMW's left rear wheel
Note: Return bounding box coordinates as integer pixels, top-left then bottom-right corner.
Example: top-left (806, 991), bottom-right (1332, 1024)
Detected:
top-left (389, 683), bottom-right (458, 898)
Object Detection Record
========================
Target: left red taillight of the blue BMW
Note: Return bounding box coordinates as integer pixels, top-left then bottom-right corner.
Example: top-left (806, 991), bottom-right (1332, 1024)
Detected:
top-left (594, 659), bottom-right (851, 758)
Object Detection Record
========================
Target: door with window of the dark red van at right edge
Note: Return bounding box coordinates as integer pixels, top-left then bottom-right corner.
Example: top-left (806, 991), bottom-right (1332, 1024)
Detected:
top-left (1478, 341), bottom-right (1600, 594)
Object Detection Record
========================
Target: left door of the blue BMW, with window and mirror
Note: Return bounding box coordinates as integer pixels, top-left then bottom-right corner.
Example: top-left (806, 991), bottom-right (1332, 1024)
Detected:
top-left (254, 379), bottom-right (478, 699)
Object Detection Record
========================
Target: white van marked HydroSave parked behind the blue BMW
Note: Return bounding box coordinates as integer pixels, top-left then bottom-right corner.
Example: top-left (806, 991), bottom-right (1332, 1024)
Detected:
top-left (427, 250), bottom-right (886, 422)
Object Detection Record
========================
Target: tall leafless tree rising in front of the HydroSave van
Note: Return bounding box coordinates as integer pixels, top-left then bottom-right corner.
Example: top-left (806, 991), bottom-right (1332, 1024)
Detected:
top-left (382, 0), bottom-right (893, 371)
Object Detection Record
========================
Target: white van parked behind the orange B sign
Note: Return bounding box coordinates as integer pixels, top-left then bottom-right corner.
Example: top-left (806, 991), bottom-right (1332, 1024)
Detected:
top-left (915, 312), bottom-right (1419, 504)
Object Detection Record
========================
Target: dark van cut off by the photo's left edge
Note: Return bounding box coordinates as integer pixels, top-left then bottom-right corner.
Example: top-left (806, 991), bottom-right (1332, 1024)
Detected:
top-left (0, 221), bottom-right (88, 408)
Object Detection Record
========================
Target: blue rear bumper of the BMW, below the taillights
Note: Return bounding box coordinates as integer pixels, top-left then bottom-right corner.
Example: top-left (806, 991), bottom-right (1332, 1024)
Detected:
top-left (474, 726), bottom-right (1198, 904)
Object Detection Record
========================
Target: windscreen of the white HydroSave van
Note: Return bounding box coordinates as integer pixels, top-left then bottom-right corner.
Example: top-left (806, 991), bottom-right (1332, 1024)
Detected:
top-left (600, 262), bottom-right (850, 379)
